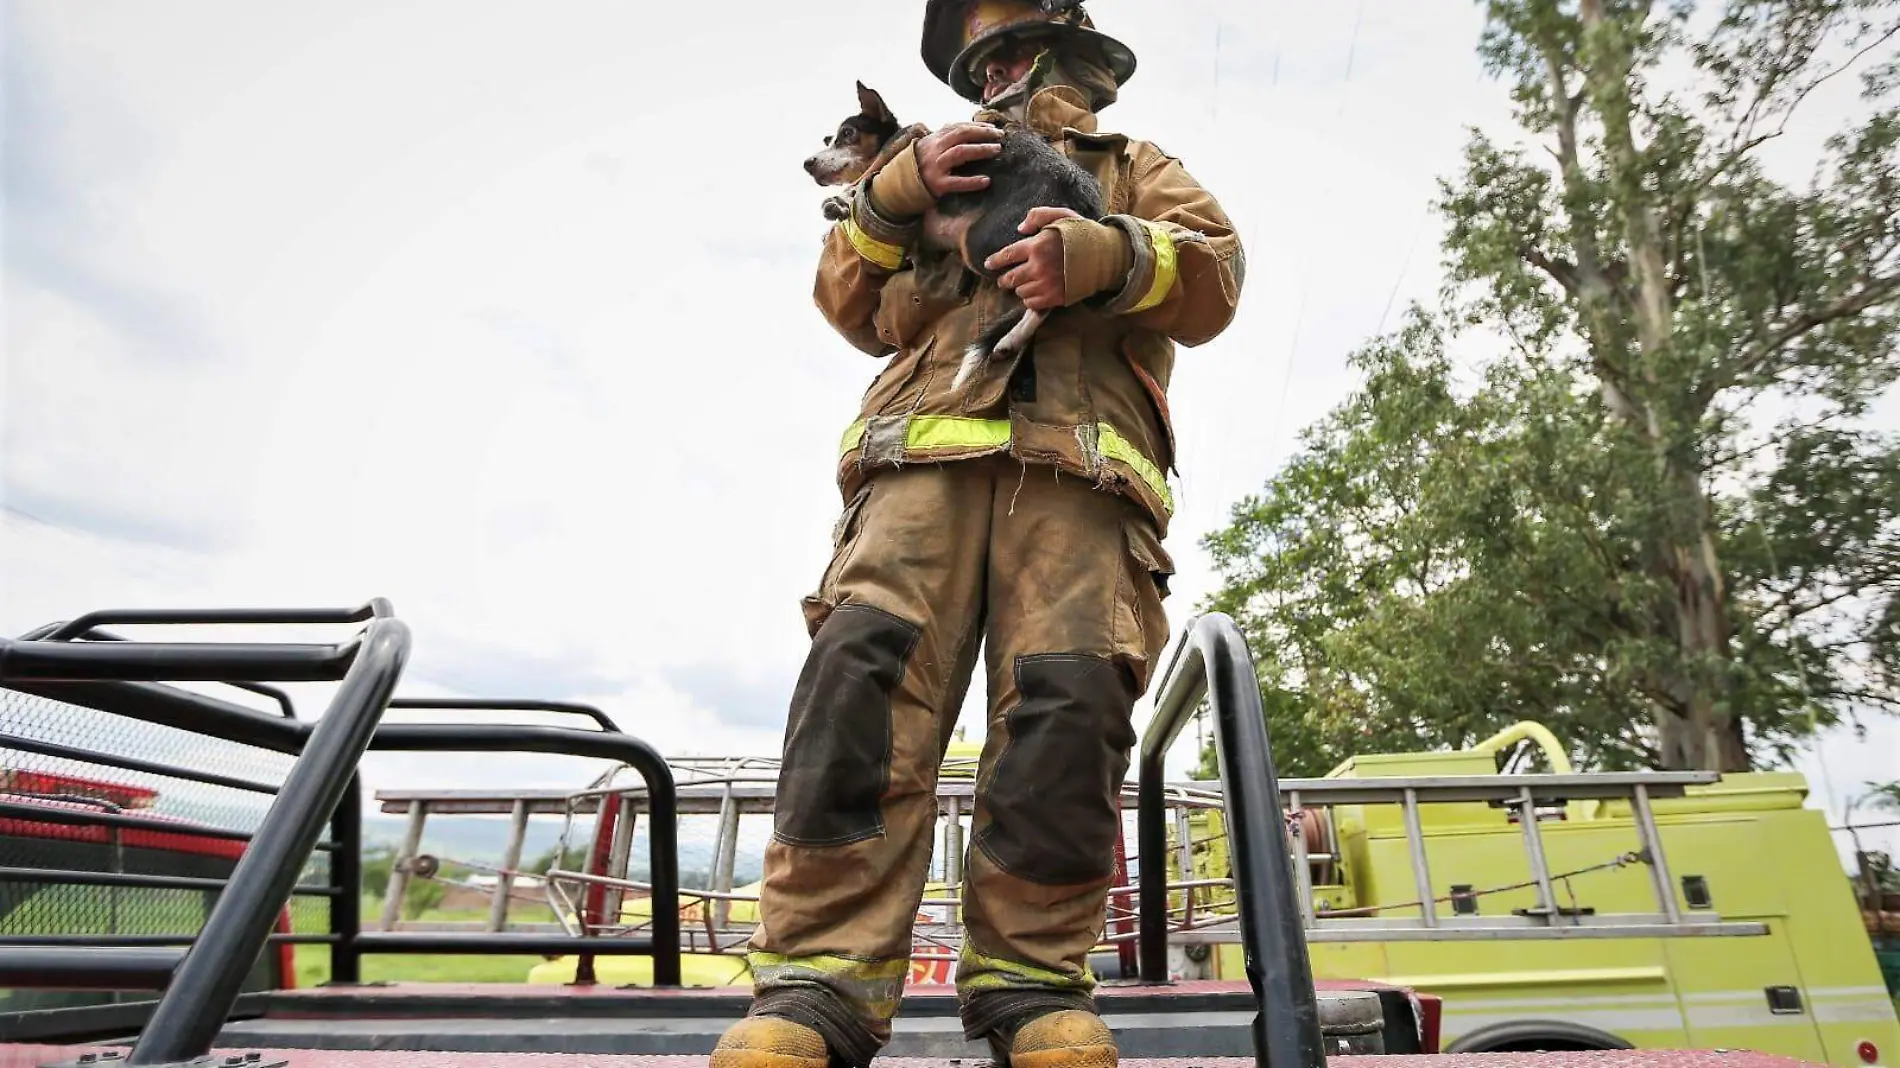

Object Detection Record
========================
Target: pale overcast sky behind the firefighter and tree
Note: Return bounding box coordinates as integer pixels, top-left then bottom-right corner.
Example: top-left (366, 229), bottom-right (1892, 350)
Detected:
top-left (0, 0), bottom-right (1900, 855)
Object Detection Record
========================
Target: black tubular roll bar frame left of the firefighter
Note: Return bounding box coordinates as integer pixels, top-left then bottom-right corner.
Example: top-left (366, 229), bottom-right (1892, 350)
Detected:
top-left (0, 601), bottom-right (680, 1066)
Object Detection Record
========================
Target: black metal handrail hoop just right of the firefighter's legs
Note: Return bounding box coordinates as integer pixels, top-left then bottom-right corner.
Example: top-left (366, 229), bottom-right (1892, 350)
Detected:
top-left (1138, 612), bottom-right (1326, 1068)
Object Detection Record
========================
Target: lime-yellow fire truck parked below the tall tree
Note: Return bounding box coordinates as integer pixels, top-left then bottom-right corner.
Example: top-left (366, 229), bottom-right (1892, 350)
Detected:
top-left (1169, 722), bottom-right (1900, 1066)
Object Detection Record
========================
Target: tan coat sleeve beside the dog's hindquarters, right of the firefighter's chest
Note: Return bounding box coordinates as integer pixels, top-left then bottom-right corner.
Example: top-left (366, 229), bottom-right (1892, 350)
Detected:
top-left (1102, 144), bottom-right (1246, 348)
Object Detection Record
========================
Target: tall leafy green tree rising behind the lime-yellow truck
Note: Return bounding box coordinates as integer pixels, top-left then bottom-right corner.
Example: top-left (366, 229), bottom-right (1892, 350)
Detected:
top-left (1208, 0), bottom-right (1900, 772)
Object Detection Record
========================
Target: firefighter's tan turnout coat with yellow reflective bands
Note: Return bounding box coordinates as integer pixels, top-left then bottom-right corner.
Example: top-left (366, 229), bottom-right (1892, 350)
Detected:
top-left (813, 86), bottom-right (1246, 539)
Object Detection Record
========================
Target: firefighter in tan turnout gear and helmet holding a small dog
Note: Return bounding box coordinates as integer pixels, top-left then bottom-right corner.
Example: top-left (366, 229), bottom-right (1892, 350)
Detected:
top-left (713, 0), bottom-right (1246, 1068)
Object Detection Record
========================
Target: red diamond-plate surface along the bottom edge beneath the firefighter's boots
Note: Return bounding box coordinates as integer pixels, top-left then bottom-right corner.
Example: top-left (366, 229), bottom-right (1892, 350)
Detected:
top-left (0, 1045), bottom-right (1839, 1068)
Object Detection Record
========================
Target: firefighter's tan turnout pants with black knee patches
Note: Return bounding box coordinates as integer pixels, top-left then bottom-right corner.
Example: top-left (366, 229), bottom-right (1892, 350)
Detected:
top-left (749, 456), bottom-right (1172, 1062)
